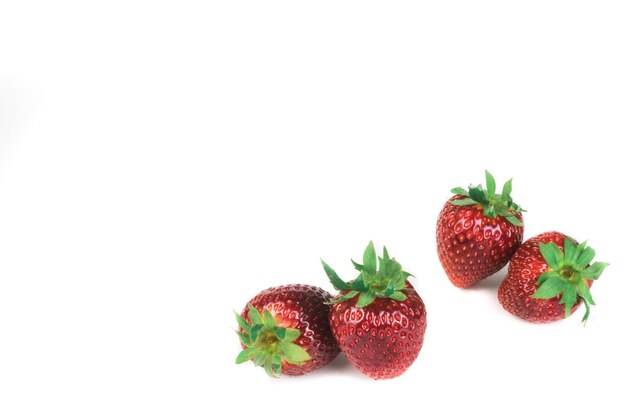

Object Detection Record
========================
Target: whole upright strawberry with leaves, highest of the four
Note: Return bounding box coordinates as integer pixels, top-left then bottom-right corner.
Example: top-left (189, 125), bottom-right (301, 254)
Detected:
top-left (437, 171), bottom-right (524, 288)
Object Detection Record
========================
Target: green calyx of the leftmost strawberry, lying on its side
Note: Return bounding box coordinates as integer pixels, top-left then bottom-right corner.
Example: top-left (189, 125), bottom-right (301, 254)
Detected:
top-left (235, 304), bottom-right (311, 377)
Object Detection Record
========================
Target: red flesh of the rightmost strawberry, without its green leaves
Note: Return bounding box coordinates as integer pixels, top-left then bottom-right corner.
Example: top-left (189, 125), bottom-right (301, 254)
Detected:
top-left (498, 232), bottom-right (591, 323)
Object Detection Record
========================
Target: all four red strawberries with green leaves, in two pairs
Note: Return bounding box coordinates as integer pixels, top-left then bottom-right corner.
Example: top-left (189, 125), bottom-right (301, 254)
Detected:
top-left (236, 171), bottom-right (608, 379)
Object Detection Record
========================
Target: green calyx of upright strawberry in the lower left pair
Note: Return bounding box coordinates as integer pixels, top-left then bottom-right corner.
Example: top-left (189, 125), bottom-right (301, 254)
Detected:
top-left (322, 241), bottom-right (411, 307)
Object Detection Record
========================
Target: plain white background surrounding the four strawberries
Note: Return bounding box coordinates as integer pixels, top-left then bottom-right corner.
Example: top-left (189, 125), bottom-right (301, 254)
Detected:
top-left (0, 1), bottom-right (626, 417)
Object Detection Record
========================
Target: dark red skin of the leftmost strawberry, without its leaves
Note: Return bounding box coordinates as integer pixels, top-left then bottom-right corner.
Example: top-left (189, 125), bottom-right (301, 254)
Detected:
top-left (239, 285), bottom-right (339, 376)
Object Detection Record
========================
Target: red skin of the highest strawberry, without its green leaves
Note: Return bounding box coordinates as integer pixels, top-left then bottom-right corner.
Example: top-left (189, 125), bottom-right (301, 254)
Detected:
top-left (436, 195), bottom-right (524, 288)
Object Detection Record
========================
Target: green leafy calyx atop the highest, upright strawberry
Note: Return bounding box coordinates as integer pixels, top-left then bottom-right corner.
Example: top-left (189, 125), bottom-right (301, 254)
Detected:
top-left (450, 170), bottom-right (526, 226)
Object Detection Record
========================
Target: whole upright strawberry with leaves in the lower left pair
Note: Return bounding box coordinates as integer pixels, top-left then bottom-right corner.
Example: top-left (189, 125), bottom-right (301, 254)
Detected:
top-left (322, 242), bottom-right (426, 379)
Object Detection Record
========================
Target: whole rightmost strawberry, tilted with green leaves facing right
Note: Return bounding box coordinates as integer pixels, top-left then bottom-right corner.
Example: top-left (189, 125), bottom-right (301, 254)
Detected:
top-left (498, 232), bottom-right (608, 323)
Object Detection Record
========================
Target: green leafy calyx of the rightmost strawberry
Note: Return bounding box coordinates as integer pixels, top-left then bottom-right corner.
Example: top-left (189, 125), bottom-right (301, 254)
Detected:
top-left (533, 237), bottom-right (608, 323)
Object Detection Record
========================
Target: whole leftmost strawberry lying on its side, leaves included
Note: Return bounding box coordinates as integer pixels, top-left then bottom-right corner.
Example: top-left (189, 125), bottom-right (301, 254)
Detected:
top-left (235, 285), bottom-right (339, 376)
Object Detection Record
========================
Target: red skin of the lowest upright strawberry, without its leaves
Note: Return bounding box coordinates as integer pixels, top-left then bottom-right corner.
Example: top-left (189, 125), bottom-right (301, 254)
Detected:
top-left (330, 283), bottom-right (426, 379)
